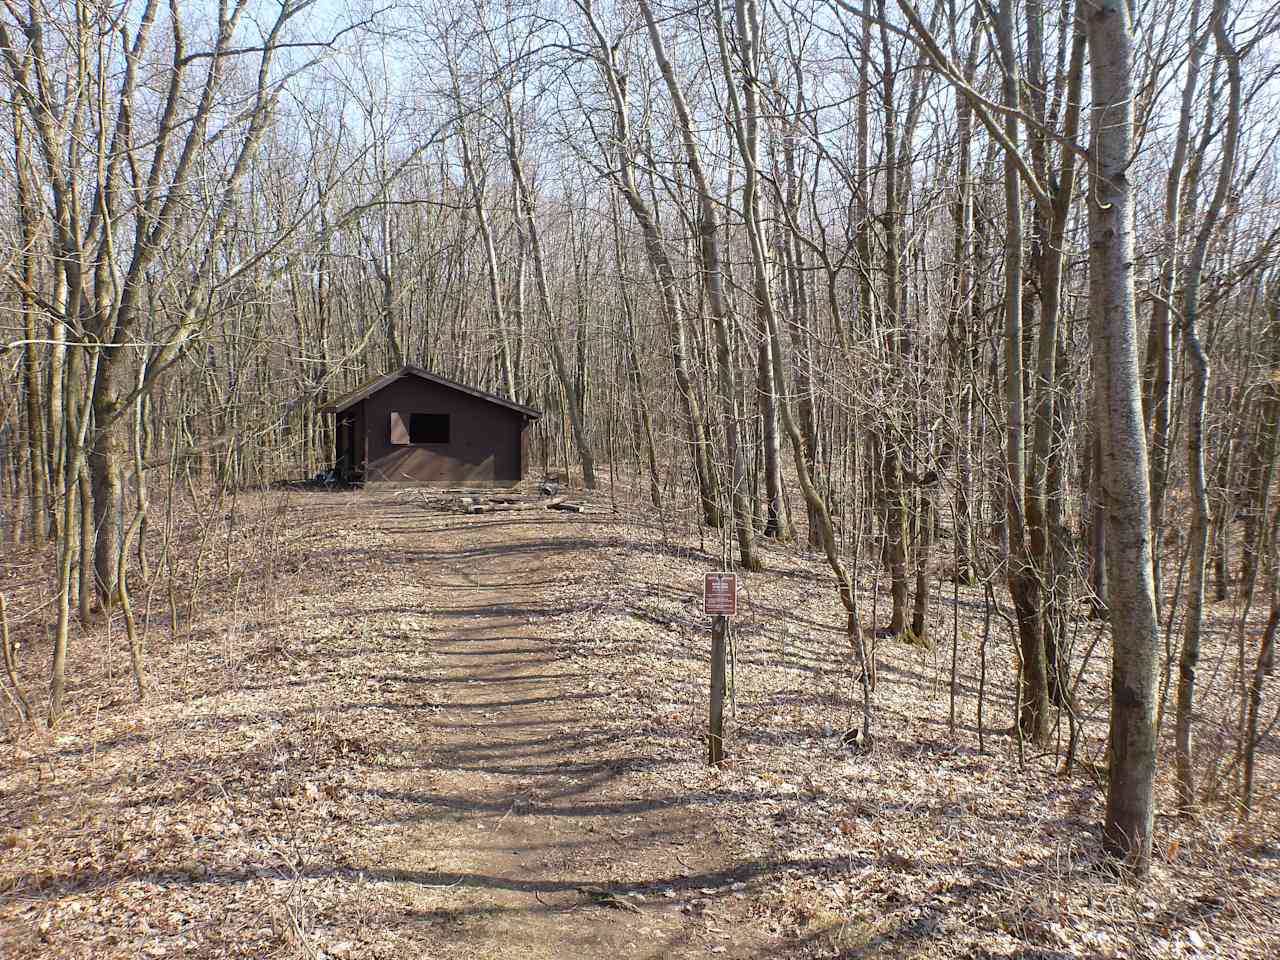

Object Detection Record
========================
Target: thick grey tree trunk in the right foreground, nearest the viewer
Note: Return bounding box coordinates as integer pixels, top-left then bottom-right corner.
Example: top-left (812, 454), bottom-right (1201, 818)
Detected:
top-left (1084, 0), bottom-right (1157, 874)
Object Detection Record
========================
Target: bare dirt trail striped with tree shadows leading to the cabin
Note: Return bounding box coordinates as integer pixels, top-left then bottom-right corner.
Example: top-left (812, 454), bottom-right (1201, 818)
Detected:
top-left (358, 508), bottom-right (771, 960)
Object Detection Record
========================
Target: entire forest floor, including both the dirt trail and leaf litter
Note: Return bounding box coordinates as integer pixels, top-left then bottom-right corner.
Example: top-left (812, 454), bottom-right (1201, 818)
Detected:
top-left (0, 483), bottom-right (1280, 960)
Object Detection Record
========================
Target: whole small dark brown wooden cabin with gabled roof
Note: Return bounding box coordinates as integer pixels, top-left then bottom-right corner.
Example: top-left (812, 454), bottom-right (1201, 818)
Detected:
top-left (324, 366), bottom-right (541, 485)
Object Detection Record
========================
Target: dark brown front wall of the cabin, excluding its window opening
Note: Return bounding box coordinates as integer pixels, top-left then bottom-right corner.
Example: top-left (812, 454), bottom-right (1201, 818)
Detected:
top-left (357, 376), bottom-right (525, 484)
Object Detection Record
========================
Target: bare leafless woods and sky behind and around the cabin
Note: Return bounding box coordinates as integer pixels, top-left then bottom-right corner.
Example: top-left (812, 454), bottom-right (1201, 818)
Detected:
top-left (0, 0), bottom-right (1280, 869)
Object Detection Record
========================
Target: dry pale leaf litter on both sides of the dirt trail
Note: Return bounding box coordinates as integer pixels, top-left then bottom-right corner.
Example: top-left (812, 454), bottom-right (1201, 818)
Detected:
top-left (0, 494), bottom-right (1280, 959)
